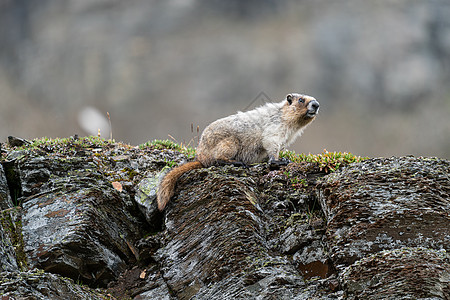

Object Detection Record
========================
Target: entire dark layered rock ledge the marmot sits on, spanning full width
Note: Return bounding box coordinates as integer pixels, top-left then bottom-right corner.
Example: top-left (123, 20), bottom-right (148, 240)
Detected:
top-left (0, 139), bottom-right (450, 299)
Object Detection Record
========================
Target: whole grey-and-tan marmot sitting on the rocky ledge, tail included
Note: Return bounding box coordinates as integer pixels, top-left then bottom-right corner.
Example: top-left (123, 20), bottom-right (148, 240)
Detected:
top-left (157, 93), bottom-right (319, 211)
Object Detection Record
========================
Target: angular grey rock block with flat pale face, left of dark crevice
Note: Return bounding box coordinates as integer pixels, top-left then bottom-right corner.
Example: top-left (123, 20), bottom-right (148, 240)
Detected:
top-left (23, 181), bottom-right (142, 286)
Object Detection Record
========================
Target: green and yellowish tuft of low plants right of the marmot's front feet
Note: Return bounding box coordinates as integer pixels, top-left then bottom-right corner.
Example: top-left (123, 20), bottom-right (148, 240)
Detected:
top-left (280, 149), bottom-right (368, 173)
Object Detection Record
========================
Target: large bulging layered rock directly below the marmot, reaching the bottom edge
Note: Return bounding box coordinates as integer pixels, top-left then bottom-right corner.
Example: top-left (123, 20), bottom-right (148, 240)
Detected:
top-left (159, 166), bottom-right (332, 299)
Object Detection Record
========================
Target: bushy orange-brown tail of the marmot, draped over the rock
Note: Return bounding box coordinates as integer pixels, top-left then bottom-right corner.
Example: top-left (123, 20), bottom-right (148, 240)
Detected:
top-left (156, 161), bottom-right (203, 211)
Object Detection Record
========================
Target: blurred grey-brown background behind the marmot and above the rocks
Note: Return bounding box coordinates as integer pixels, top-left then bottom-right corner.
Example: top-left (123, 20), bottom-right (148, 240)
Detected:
top-left (0, 0), bottom-right (450, 158)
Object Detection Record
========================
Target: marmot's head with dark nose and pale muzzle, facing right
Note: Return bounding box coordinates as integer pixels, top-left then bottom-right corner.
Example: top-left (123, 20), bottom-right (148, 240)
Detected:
top-left (284, 93), bottom-right (320, 126)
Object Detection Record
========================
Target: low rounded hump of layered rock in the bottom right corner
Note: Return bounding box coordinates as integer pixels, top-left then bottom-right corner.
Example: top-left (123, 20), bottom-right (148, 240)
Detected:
top-left (342, 247), bottom-right (450, 299)
